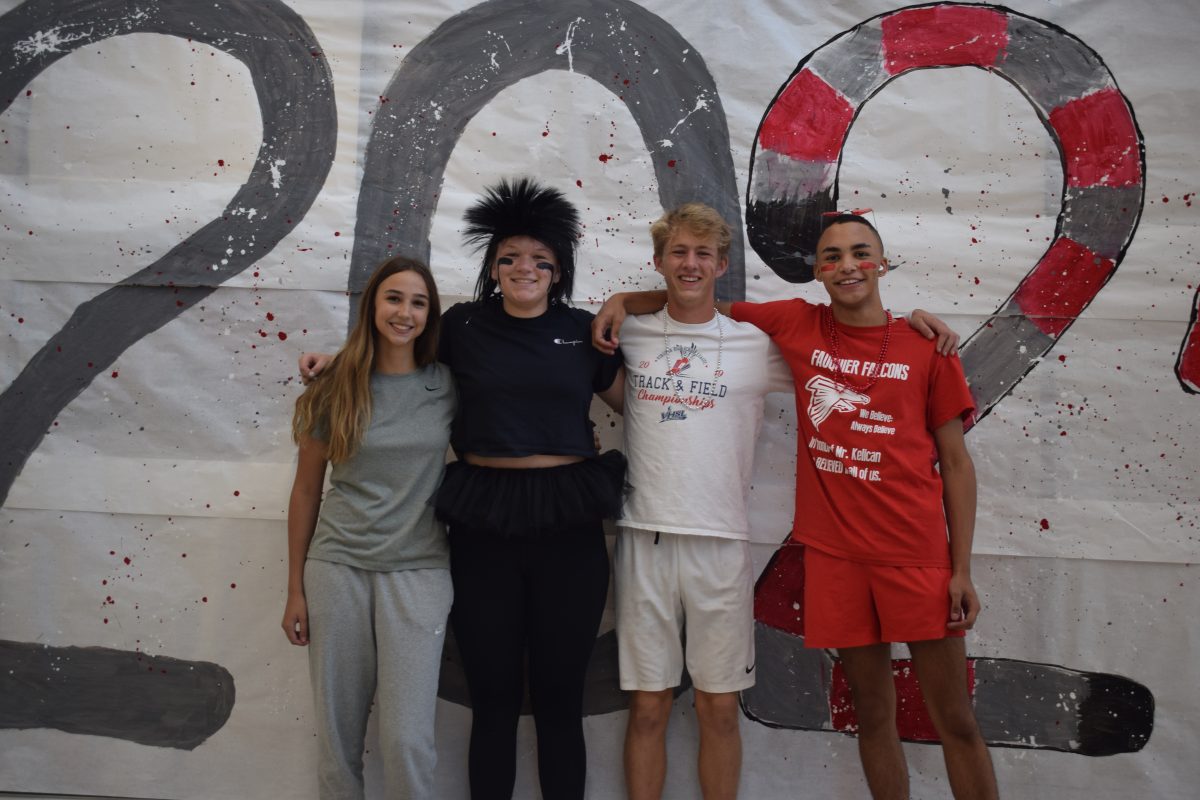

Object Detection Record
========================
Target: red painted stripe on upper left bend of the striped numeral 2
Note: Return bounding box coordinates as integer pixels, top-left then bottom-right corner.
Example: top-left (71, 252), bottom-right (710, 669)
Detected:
top-left (758, 70), bottom-right (854, 162)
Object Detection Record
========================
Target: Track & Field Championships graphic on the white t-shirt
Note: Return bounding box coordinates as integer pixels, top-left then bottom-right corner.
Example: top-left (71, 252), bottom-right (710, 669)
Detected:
top-left (628, 342), bottom-right (728, 422)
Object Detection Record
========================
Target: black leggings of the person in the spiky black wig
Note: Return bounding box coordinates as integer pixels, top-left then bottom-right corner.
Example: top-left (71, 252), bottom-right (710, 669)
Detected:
top-left (450, 521), bottom-right (608, 800)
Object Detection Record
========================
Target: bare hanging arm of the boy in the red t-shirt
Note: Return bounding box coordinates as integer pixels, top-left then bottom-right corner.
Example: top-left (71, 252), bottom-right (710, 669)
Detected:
top-left (934, 417), bottom-right (980, 631)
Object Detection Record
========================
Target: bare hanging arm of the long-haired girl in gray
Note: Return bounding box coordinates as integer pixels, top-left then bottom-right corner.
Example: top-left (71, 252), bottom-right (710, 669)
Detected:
top-left (282, 437), bottom-right (328, 645)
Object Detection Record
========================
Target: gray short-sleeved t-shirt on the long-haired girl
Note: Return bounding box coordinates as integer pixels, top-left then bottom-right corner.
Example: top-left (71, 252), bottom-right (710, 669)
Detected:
top-left (308, 363), bottom-right (455, 571)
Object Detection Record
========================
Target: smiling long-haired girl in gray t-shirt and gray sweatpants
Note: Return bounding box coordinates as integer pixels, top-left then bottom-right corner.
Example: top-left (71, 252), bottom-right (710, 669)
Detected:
top-left (283, 258), bottom-right (455, 800)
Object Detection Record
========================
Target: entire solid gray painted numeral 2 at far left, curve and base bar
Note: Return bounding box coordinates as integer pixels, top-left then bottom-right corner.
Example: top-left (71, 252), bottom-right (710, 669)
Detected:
top-left (0, 0), bottom-right (337, 748)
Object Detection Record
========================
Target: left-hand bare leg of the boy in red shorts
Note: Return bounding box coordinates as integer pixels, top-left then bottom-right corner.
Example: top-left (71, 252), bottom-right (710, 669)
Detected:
top-left (838, 643), bottom-right (908, 800)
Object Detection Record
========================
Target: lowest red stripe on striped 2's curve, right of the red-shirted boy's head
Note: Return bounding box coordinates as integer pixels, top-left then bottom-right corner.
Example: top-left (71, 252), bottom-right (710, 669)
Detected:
top-left (1014, 236), bottom-right (1116, 336)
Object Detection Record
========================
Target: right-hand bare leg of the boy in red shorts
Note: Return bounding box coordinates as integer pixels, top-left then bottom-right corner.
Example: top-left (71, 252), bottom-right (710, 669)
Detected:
top-left (908, 638), bottom-right (1000, 800)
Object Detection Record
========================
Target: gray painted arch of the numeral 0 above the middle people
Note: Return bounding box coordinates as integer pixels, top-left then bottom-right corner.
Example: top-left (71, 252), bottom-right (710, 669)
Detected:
top-left (349, 0), bottom-right (745, 325)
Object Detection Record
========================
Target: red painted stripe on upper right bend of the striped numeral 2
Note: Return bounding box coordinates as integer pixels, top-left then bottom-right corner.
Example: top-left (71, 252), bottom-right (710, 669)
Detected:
top-left (1050, 89), bottom-right (1141, 186)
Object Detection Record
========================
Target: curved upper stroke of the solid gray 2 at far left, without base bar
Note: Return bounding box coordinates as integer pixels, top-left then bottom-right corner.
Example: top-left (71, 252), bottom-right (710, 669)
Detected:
top-left (0, 0), bottom-right (337, 505)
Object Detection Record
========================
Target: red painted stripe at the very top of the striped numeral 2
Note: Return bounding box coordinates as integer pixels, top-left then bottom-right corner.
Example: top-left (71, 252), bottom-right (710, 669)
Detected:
top-left (883, 6), bottom-right (1008, 74)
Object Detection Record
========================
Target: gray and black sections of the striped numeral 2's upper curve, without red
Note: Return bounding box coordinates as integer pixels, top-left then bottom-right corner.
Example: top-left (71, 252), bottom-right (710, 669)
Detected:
top-left (746, 2), bottom-right (1147, 425)
